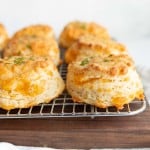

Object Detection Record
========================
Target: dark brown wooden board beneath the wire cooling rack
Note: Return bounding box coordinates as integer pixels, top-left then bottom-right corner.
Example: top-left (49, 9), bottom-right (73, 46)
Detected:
top-left (0, 108), bottom-right (150, 149)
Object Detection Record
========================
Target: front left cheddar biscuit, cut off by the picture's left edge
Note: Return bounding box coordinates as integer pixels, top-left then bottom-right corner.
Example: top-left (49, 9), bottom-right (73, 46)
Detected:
top-left (0, 56), bottom-right (64, 110)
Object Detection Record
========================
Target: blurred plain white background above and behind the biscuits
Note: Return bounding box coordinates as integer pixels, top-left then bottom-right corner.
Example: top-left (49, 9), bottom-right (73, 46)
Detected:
top-left (0, 0), bottom-right (150, 67)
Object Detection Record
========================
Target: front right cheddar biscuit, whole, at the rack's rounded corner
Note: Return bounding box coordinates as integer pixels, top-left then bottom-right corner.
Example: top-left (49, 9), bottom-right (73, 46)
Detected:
top-left (67, 55), bottom-right (144, 109)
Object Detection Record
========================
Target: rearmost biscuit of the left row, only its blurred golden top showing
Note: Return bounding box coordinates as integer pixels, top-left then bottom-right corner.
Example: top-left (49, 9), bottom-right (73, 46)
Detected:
top-left (14, 25), bottom-right (54, 38)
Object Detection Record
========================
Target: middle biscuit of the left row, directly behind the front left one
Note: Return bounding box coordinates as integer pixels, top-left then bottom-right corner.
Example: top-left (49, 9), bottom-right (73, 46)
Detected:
top-left (4, 36), bottom-right (59, 57)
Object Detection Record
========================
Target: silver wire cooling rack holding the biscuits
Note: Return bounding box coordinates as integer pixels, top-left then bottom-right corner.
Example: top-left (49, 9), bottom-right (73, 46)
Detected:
top-left (0, 64), bottom-right (146, 119)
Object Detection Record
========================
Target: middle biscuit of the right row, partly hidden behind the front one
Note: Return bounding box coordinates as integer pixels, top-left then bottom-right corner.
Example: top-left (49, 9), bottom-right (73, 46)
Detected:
top-left (65, 35), bottom-right (127, 63)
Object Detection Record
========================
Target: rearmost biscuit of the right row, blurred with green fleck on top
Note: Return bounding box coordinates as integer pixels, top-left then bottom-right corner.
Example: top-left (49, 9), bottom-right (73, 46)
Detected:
top-left (59, 21), bottom-right (110, 48)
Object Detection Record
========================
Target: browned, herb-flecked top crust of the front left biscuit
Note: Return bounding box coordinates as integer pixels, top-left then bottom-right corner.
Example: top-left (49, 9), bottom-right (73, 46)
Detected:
top-left (0, 56), bottom-right (54, 72)
